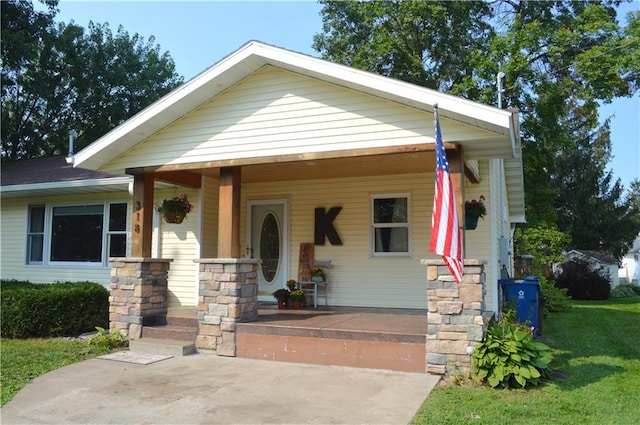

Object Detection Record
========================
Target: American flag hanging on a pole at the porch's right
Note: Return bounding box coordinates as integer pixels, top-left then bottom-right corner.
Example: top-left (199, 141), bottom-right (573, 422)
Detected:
top-left (429, 106), bottom-right (464, 283)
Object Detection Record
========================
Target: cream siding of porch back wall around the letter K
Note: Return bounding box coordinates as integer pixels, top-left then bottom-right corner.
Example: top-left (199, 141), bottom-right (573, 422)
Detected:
top-left (241, 173), bottom-right (435, 309)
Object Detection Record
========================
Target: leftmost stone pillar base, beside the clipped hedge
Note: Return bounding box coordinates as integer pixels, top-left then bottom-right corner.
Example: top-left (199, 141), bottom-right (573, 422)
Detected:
top-left (109, 257), bottom-right (173, 339)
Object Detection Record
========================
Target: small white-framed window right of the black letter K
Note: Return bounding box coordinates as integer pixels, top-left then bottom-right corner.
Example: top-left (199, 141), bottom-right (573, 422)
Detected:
top-left (371, 194), bottom-right (409, 257)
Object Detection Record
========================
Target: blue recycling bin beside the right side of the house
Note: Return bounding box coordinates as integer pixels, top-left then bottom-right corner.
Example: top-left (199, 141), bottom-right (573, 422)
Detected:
top-left (499, 276), bottom-right (542, 335)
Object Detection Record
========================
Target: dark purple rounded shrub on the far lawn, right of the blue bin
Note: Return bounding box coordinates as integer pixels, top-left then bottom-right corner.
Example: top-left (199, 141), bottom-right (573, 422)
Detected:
top-left (556, 260), bottom-right (611, 300)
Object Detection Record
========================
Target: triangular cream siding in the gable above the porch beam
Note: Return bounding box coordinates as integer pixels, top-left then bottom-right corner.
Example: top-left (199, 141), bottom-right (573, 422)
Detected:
top-left (102, 66), bottom-right (493, 171)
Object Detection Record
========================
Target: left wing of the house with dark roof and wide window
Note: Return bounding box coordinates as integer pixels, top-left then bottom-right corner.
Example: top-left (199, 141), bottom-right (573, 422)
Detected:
top-left (0, 156), bottom-right (132, 285)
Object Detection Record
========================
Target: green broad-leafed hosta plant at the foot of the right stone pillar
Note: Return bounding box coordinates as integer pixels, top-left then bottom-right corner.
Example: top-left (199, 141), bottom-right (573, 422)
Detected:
top-left (471, 310), bottom-right (553, 388)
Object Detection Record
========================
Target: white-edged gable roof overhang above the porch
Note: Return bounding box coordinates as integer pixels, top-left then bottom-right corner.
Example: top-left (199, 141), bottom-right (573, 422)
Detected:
top-left (74, 41), bottom-right (524, 222)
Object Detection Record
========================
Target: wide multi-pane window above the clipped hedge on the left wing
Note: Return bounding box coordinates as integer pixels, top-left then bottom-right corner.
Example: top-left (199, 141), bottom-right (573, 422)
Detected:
top-left (27, 203), bottom-right (127, 264)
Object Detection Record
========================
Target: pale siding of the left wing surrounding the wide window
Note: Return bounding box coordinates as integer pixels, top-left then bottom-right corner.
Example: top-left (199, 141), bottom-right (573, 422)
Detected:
top-left (0, 193), bottom-right (131, 286)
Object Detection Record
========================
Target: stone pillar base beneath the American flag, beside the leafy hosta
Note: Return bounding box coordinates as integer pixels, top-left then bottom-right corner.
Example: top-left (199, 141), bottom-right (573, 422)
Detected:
top-left (422, 260), bottom-right (487, 375)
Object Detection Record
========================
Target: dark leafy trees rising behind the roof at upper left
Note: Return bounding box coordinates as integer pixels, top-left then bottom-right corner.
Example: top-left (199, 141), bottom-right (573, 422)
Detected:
top-left (1, 0), bottom-right (182, 160)
